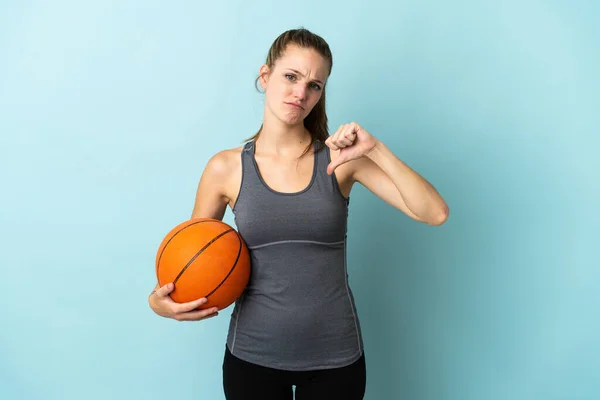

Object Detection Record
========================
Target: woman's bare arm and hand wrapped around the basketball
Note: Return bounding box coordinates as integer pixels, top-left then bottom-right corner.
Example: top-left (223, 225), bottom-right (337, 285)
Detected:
top-left (148, 151), bottom-right (231, 321)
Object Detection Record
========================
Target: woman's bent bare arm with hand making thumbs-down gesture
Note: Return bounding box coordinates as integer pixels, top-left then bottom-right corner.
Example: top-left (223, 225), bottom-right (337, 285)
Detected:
top-left (325, 123), bottom-right (449, 225)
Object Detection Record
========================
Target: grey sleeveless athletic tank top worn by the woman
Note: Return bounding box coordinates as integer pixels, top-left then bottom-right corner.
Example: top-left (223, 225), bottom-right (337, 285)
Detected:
top-left (227, 141), bottom-right (363, 371)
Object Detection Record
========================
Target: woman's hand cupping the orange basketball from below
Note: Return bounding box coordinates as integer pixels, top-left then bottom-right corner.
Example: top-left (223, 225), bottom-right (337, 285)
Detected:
top-left (148, 283), bottom-right (219, 321)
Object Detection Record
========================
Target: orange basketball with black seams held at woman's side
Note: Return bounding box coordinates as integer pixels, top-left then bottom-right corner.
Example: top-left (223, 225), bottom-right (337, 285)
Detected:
top-left (156, 218), bottom-right (250, 310)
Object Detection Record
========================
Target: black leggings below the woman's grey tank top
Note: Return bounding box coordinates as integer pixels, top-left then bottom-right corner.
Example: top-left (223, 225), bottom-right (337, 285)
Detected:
top-left (223, 347), bottom-right (366, 400)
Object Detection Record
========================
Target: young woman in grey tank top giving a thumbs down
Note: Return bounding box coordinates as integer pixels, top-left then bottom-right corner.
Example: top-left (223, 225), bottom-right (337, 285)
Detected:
top-left (149, 29), bottom-right (448, 400)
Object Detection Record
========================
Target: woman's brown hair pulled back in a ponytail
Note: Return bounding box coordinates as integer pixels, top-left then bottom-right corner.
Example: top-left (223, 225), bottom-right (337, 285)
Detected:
top-left (246, 28), bottom-right (333, 157)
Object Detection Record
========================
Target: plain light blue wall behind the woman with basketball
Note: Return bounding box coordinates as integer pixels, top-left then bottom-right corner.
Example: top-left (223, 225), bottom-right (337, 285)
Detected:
top-left (0, 0), bottom-right (600, 400)
